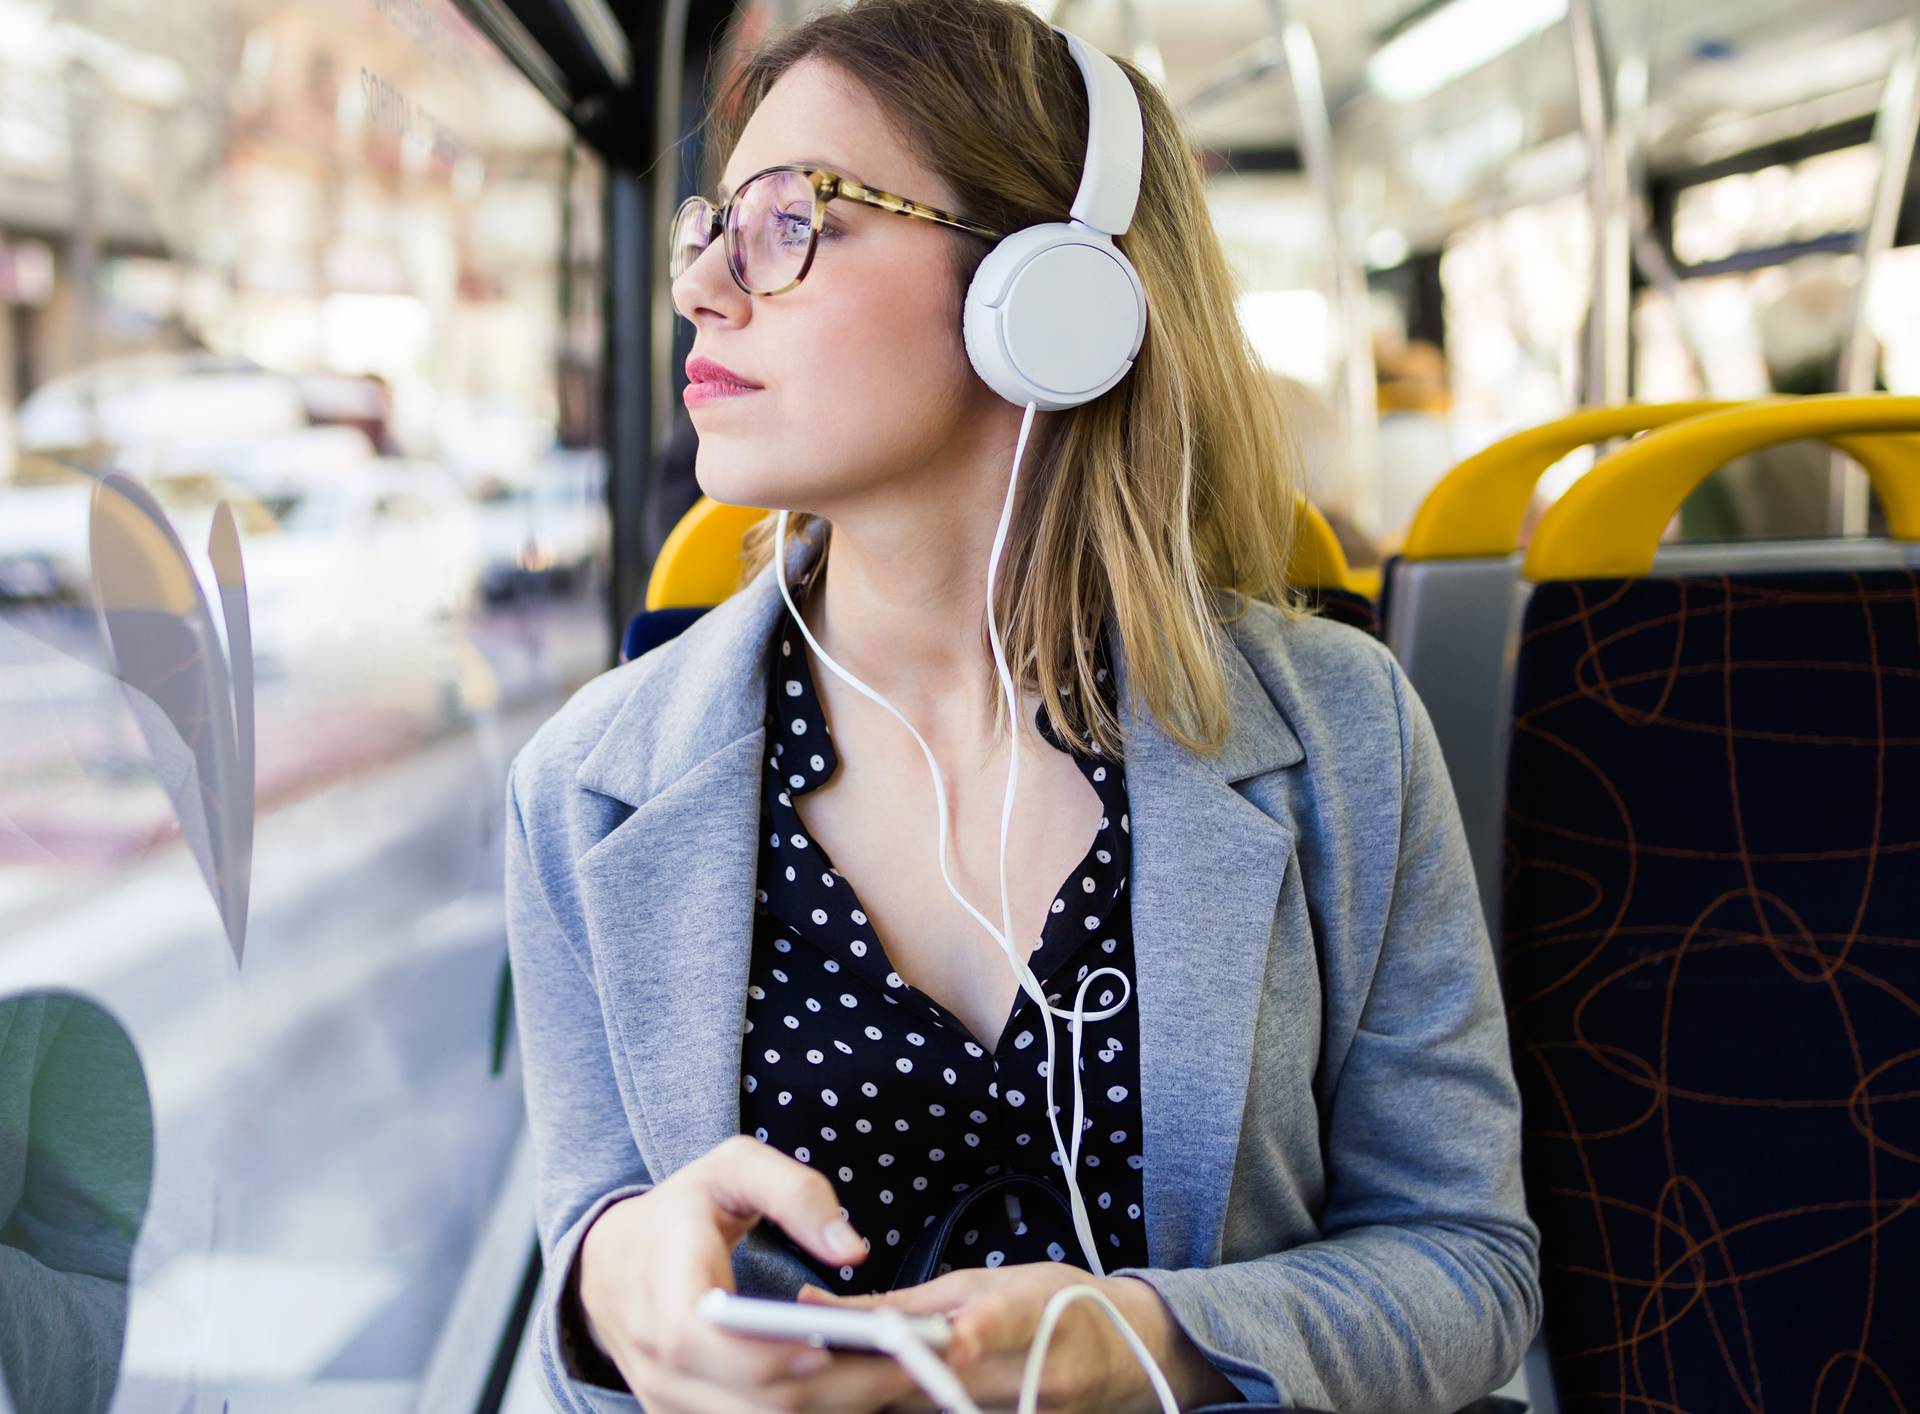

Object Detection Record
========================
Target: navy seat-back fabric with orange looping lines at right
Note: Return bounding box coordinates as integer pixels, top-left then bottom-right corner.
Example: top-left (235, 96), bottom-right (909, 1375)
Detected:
top-left (1503, 571), bottom-right (1920, 1414)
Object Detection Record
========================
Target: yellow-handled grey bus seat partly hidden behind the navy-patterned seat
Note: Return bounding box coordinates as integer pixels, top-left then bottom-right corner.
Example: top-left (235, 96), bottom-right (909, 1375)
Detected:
top-left (1382, 400), bottom-right (1912, 938)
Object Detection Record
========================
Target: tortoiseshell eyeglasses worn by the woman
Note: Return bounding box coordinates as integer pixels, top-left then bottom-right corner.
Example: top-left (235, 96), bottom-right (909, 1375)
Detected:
top-left (666, 165), bottom-right (1000, 296)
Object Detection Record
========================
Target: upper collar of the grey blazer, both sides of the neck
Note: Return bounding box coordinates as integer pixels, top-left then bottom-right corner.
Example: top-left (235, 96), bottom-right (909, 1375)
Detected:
top-left (574, 536), bottom-right (1304, 807)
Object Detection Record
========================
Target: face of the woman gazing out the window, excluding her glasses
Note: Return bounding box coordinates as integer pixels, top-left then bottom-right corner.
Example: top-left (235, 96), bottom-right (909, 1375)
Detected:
top-left (674, 60), bottom-right (1012, 517)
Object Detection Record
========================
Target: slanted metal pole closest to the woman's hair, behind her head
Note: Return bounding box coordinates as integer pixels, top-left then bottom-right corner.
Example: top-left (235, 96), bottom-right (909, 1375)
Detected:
top-left (1267, 0), bottom-right (1380, 530)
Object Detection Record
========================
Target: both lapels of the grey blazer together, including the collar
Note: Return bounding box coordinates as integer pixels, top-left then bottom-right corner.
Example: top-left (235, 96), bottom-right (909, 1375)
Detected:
top-left (574, 540), bottom-right (1302, 1266)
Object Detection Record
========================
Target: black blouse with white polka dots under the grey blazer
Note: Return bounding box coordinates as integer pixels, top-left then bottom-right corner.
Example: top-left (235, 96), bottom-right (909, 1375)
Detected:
top-left (741, 615), bottom-right (1146, 1293)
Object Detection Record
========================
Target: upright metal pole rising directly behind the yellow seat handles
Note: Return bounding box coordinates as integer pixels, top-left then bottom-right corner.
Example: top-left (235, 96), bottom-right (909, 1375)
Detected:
top-left (1567, 0), bottom-right (1632, 405)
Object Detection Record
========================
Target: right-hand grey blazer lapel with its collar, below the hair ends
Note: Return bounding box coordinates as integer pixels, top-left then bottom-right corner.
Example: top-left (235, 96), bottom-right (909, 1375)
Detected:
top-left (1116, 603), bottom-right (1304, 1268)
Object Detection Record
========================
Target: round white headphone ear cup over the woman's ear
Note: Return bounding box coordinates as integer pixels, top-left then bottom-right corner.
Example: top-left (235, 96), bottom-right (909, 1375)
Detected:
top-left (962, 223), bottom-right (1146, 411)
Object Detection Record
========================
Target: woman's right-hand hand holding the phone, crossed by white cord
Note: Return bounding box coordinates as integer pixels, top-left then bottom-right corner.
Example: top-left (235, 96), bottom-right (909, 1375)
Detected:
top-left (801, 1262), bottom-right (1240, 1414)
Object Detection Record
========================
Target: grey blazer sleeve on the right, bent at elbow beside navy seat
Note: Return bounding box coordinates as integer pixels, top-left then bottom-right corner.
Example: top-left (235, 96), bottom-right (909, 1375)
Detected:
top-left (1116, 661), bottom-right (1540, 1414)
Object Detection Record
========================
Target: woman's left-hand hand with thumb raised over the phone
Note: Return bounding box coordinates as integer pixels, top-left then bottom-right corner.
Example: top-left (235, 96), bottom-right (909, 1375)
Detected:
top-left (580, 1135), bottom-right (914, 1414)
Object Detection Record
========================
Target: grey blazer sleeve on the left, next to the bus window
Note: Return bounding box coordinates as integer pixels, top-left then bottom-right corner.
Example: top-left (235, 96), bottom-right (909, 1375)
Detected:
top-left (507, 759), bottom-right (653, 1414)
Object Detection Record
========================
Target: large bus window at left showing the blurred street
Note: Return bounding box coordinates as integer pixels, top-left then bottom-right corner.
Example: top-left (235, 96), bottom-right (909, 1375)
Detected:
top-left (0, 0), bottom-right (611, 1410)
